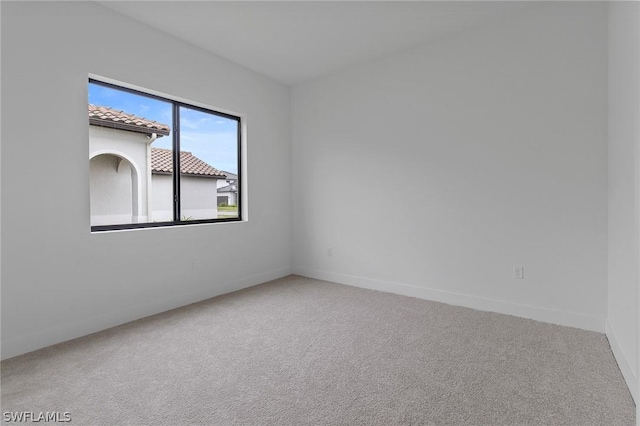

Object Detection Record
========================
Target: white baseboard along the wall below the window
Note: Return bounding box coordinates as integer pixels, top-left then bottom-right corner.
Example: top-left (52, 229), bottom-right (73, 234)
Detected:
top-left (2, 268), bottom-right (291, 360)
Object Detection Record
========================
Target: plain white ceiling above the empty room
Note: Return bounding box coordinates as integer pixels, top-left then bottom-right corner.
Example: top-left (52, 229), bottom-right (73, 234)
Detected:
top-left (98, 1), bottom-right (535, 85)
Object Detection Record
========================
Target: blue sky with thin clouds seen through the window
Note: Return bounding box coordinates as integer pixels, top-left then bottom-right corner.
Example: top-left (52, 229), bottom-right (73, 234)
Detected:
top-left (89, 83), bottom-right (238, 173)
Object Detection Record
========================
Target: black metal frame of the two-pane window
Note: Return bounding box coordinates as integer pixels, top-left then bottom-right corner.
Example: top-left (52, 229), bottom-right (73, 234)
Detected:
top-left (88, 77), bottom-right (243, 232)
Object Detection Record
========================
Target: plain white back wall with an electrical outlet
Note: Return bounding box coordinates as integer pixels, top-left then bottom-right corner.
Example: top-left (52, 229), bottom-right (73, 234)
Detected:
top-left (292, 2), bottom-right (607, 331)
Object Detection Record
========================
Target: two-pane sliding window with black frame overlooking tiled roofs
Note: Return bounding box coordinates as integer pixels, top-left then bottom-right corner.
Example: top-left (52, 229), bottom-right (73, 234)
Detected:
top-left (88, 79), bottom-right (242, 231)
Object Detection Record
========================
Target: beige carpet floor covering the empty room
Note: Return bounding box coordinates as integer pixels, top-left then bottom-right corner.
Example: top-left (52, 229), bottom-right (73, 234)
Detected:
top-left (1, 276), bottom-right (635, 425)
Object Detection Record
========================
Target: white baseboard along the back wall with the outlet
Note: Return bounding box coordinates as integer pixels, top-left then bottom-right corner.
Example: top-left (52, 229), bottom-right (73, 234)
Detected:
top-left (293, 267), bottom-right (605, 333)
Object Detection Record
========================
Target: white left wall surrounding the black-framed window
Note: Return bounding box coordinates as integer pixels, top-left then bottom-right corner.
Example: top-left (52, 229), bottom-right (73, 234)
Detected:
top-left (1, 2), bottom-right (291, 358)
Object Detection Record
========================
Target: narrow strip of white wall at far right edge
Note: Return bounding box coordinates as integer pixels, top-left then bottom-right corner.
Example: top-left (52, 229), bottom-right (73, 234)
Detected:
top-left (607, 2), bottom-right (640, 404)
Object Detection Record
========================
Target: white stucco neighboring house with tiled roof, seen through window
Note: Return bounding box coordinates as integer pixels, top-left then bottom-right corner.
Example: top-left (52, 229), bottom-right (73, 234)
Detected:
top-left (89, 105), bottom-right (226, 226)
